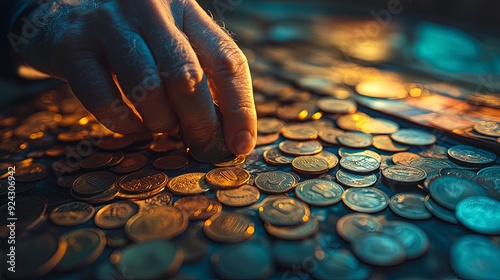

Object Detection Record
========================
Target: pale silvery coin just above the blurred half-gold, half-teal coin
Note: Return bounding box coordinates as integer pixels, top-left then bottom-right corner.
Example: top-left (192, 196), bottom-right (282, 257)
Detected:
top-left (342, 187), bottom-right (389, 213)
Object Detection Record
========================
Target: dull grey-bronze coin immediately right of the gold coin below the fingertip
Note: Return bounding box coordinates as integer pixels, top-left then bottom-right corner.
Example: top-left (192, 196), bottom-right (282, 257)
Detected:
top-left (254, 171), bottom-right (297, 193)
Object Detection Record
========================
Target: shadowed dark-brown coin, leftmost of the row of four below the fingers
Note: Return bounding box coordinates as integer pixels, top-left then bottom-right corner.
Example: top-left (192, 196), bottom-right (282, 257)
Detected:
top-left (72, 171), bottom-right (116, 195)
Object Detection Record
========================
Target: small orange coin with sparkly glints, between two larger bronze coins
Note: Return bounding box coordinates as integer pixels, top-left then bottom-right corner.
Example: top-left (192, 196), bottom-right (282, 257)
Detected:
top-left (174, 195), bottom-right (222, 220)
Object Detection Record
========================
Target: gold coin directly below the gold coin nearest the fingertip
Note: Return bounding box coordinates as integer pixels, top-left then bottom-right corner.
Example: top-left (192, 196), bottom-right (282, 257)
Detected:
top-left (216, 185), bottom-right (260, 207)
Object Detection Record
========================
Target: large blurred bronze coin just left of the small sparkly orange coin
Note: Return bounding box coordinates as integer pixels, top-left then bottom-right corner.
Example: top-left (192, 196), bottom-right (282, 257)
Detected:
top-left (125, 206), bottom-right (189, 243)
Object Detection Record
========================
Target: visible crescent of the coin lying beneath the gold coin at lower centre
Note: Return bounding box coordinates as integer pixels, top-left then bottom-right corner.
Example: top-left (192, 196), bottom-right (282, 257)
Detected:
top-left (264, 218), bottom-right (319, 240)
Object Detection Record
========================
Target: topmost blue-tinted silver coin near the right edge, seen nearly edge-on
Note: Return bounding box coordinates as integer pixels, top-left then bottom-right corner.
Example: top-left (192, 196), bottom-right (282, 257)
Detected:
top-left (448, 145), bottom-right (496, 166)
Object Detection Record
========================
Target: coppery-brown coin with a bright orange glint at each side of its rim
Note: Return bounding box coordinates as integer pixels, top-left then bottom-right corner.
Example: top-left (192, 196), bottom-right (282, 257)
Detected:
top-left (203, 212), bottom-right (255, 243)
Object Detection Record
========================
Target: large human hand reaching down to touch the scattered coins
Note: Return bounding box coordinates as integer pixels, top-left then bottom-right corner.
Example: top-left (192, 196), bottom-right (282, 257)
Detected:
top-left (19, 0), bottom-right (256, 154)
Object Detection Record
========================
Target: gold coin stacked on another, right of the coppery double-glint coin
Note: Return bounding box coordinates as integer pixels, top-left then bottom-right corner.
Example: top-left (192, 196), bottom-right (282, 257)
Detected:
top-left (259, 196), bottom-right (310, 226)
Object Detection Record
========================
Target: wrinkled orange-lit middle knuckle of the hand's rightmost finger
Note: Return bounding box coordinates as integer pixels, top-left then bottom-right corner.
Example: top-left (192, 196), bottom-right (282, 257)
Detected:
top-left (214, 39), bottom-right (248, 76)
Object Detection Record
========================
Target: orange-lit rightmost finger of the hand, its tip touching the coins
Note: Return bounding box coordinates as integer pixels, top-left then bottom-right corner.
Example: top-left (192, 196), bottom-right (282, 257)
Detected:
top-left (183, 1), bottom-right (257, 154)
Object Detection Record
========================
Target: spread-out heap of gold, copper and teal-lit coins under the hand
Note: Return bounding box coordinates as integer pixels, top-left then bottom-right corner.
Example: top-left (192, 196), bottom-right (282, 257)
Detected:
top-left (0, 47), bottom-right (500, 279)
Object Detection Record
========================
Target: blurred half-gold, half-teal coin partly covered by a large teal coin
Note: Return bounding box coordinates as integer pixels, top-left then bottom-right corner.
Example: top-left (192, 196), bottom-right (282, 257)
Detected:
top-left (336, 213), bottom-right (382, 242)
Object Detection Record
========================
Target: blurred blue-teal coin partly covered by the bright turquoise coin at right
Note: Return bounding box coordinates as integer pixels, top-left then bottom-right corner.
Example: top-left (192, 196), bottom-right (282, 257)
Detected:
top-left (429, 176), bottom-right (486, 210)
